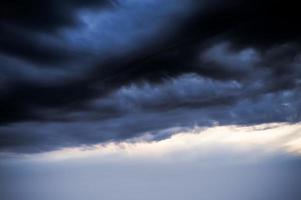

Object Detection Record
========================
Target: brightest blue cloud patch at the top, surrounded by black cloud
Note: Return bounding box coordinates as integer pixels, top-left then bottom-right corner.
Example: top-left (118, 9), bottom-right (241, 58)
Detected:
top-left (59, 0), bottom-right (195, 54)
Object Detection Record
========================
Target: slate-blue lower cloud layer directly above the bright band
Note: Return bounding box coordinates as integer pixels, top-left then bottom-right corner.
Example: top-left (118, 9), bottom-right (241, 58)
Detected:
top-left (0, 66), bottom-right (301, 152)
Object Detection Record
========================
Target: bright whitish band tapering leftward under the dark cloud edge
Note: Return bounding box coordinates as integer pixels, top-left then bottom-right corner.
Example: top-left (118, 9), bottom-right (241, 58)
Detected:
top-left (24, 123), bottom-right (301, 164)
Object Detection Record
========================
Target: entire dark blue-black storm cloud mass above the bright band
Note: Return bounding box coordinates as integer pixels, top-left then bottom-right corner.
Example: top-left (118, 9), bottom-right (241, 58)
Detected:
top-left (0, 0), bottom-right (301, 152)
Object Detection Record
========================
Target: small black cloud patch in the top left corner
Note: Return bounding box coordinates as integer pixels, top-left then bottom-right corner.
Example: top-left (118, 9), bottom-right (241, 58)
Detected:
top-left (0, 0), bottom-right (114, 31)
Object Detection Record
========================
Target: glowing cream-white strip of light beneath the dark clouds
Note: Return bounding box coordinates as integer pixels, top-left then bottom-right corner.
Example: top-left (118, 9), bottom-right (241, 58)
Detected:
top-left (29, 123), bottom-right (301, 161)
